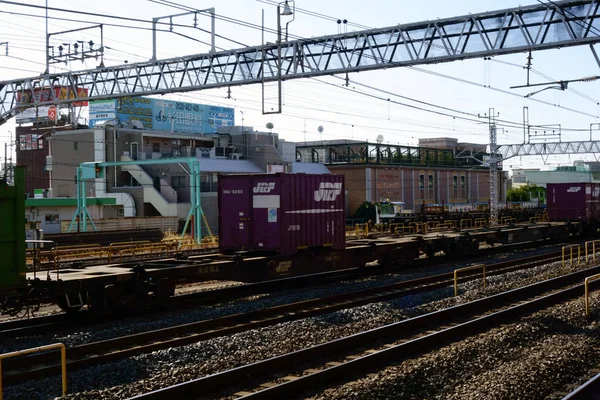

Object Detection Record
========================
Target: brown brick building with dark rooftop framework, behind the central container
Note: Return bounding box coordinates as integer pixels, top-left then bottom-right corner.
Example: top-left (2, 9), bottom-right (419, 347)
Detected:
top-left (296, 138), bottom-right (507, 215)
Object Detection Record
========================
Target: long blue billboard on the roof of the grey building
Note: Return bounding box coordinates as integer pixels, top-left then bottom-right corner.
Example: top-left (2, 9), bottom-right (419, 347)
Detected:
top-left (89, 97), bottom-right (235, 135)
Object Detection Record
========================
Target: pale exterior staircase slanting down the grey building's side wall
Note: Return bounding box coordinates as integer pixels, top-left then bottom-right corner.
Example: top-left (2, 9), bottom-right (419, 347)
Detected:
top-left (121, 155), bottom-right (191, 218)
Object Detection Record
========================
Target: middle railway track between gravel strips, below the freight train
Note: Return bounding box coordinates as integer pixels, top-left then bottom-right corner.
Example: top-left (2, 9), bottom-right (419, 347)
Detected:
top-left (3, 254), bottom-right (560, 384)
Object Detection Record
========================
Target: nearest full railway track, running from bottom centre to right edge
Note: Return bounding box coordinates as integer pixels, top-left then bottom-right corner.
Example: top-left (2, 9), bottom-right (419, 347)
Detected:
top-left (134, 267), bottom-right (600, 400)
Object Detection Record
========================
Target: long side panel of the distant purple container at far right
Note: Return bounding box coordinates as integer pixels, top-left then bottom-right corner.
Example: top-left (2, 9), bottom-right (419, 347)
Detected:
top-left (547, 183), bottom-right (591, 221)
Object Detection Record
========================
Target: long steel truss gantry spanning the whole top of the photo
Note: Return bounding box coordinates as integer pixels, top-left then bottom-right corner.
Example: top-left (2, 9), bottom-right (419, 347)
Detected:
top-left (0, 0), bottom-right (600, 124)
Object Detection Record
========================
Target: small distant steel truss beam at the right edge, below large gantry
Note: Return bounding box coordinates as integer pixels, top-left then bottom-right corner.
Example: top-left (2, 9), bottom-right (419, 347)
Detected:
top-left (496, 141), bottom-right (600, 160)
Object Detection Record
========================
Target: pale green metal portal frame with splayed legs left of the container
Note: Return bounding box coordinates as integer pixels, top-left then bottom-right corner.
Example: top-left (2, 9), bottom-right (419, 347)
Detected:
top-left (68, 157), bottom-right (203, 243)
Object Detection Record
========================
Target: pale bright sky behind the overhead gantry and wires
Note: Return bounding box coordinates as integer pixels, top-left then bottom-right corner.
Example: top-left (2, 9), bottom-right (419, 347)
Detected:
top-left (0, 0), bottom-right (600, 169)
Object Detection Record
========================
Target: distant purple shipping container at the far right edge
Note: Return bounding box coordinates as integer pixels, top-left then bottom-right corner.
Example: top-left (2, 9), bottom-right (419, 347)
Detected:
top-left (546, 183), bottom-right (600, 222)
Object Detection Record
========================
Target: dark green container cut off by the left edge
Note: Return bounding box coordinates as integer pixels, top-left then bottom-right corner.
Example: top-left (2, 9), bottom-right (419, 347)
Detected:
top-left (0, 167), bottom-right (27, 294)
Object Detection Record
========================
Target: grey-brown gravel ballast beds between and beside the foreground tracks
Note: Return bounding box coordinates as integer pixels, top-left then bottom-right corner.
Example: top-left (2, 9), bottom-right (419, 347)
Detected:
top-left (2, 245), bottom-right (600, 399)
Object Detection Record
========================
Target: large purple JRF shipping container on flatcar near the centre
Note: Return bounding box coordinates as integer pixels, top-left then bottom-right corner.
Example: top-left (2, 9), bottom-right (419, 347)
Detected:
top-left (219, 174), bottom-right (346, 255)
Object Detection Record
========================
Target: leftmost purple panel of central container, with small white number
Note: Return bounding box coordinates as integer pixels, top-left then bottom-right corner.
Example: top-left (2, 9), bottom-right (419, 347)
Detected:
top-left (219, 175), bottom-right (252, 251)
